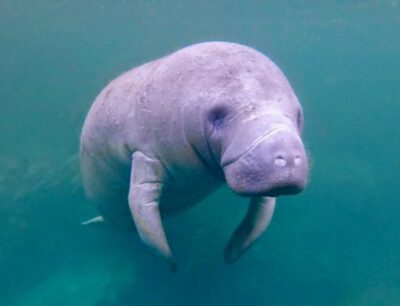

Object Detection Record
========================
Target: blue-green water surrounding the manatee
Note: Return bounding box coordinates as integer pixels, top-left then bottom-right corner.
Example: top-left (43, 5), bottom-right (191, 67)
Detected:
top-left (0, 0), bottom-right (400, 306)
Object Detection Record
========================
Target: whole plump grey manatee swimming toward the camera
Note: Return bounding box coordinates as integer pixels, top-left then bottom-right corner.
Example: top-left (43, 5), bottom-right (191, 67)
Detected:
top-left (80, 42), bottom-right (308, 267)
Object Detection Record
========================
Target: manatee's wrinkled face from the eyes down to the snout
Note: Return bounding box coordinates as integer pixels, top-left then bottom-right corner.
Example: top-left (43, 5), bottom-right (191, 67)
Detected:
top-left (208, 95), bottom-right (308, 197)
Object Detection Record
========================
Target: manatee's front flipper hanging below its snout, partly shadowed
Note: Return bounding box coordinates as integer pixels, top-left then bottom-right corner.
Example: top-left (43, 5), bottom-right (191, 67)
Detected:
top-left (224, 197), bottom-right (275, 263)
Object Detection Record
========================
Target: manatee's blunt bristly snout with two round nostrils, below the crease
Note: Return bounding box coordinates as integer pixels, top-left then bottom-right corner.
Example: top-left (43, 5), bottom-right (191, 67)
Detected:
top-left (223, 128), bottom-right (308, 197)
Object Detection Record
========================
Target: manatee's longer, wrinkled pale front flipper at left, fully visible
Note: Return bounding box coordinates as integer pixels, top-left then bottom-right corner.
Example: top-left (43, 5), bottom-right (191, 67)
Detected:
top-left (128, 152), bottom-right (176, 270)
